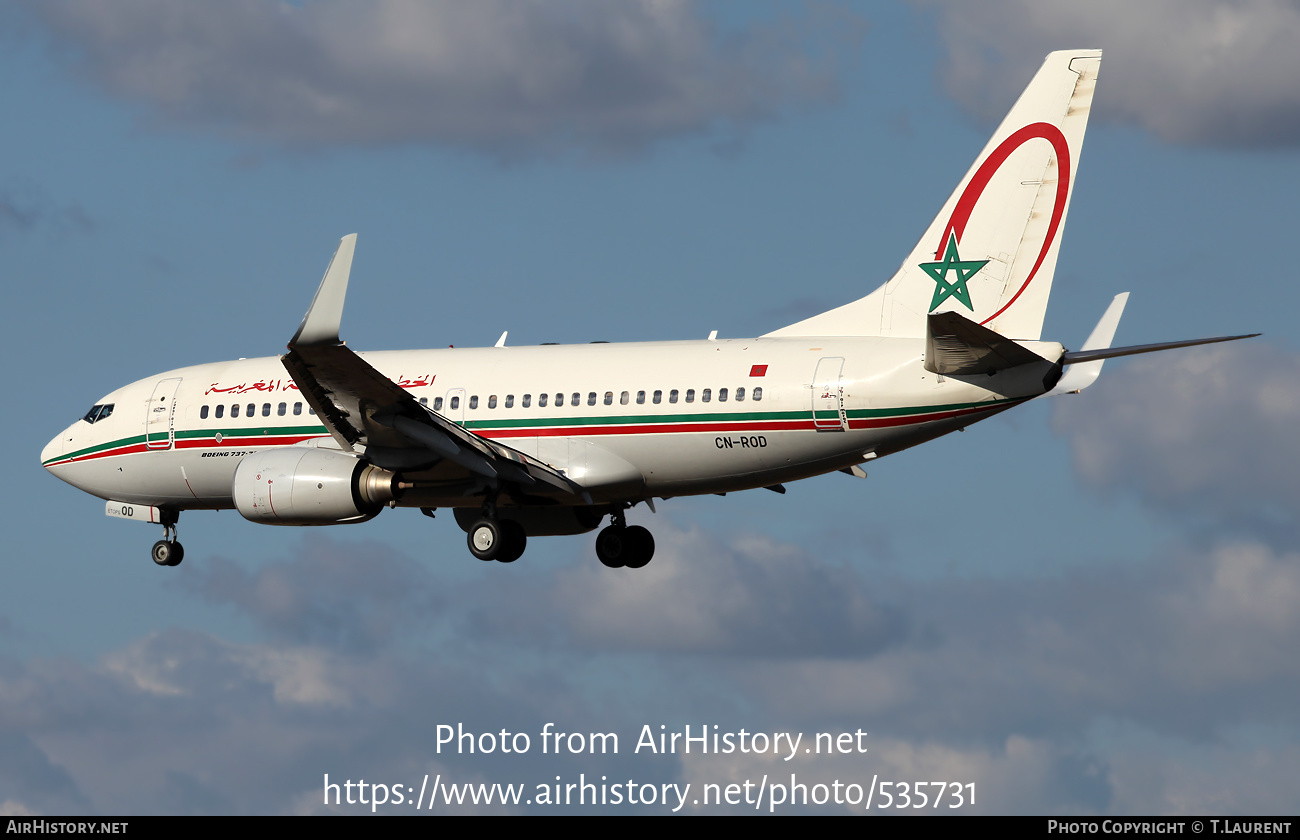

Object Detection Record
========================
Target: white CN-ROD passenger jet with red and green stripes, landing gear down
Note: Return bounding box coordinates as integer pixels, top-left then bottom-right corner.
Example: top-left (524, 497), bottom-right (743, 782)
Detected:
top-left (40, 49), bottom-right (1251, 568)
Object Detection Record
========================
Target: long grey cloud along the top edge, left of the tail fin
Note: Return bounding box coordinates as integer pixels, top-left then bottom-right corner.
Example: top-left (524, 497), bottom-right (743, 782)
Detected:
top-left (20, 0), bottom-right (861, 156)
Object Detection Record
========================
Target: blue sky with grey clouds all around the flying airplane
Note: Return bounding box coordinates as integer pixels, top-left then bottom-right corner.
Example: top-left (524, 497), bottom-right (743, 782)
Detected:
top-left (0, 0), bottom-right (1300, 814)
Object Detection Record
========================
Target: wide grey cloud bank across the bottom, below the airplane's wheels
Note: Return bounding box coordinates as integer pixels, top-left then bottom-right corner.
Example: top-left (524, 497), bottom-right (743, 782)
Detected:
top-left (0, 524), bottom-right (1300, 813)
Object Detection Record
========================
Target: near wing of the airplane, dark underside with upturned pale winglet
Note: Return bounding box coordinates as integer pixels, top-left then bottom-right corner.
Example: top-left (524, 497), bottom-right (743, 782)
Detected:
top-left (281, 234), bottom-right (592, 505)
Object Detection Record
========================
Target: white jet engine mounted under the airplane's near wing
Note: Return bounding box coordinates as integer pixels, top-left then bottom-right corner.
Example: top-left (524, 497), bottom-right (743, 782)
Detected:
top-left (231, 446), bottom-right (397, 525)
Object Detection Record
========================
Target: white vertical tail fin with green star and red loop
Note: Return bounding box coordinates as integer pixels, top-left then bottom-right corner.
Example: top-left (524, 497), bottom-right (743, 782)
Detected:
top-left (768, 49), bottom-right (1101, 341)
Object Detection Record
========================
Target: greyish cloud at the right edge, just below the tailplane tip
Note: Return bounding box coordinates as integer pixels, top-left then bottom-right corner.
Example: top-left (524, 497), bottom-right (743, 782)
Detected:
top-left (1053, 341), bottom-right (1300, 540)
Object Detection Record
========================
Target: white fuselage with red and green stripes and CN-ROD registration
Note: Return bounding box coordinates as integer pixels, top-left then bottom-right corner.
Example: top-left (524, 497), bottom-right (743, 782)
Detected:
top-left (42, 338), bottom-right (1060, 510)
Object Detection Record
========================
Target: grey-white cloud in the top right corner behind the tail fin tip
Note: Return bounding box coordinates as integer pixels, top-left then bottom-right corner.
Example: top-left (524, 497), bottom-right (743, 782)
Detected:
top-left (939, 0), bottom-right (1300, 146)
